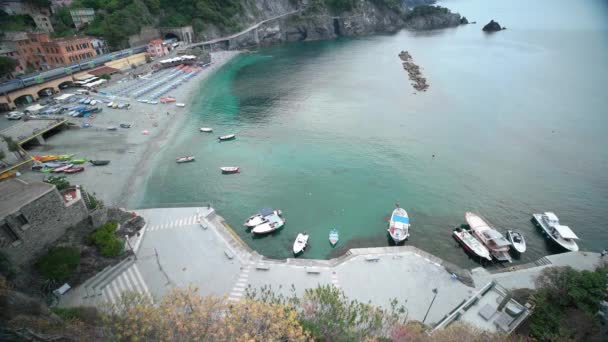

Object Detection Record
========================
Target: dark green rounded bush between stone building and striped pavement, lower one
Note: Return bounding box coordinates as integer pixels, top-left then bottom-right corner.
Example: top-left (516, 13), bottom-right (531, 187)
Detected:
top-left (36, 247), bottom-right (80, 282)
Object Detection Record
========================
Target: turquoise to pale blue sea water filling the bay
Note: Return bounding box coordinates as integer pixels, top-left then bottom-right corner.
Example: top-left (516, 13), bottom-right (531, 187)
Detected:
top-left (134, 0), bottom-right (608, 266)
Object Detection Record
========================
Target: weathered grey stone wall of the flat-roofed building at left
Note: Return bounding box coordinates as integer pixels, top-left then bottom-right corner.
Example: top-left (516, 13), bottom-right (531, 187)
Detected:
top-left (2, 189), bottom-right (88, 266)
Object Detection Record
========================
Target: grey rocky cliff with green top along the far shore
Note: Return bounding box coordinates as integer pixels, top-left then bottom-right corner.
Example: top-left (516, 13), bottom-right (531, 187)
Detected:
top-left (226, 0), bottom-right (467, 48)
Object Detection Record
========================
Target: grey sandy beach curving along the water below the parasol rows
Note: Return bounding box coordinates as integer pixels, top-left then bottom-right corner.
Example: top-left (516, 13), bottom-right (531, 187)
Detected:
top-left (21, 51), bottom-right (239, 207)
